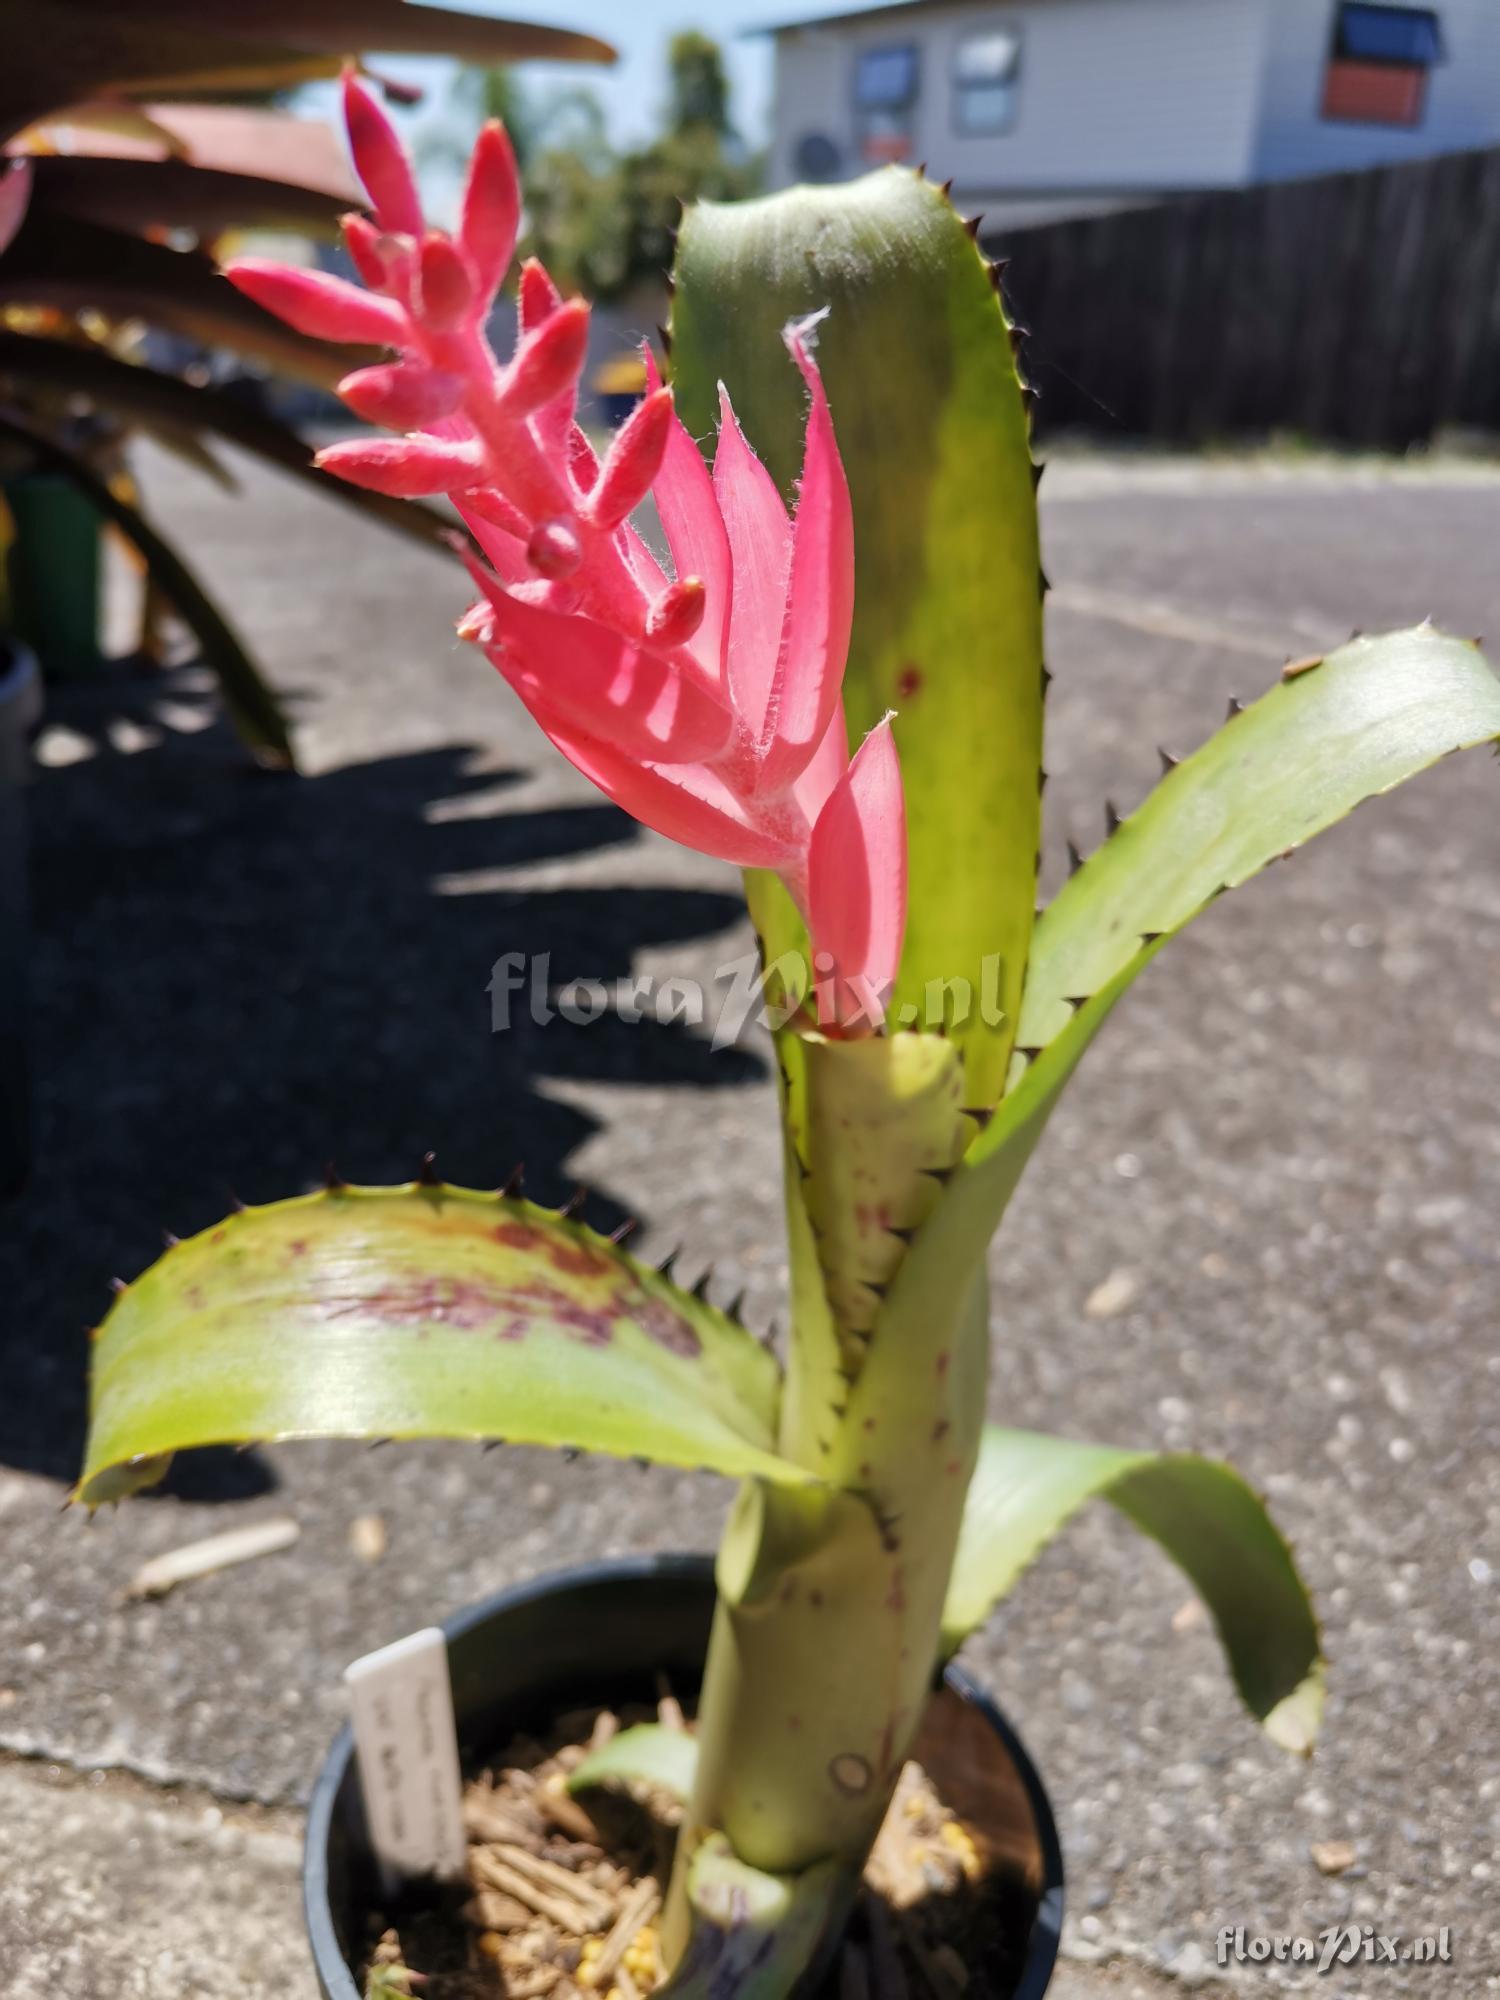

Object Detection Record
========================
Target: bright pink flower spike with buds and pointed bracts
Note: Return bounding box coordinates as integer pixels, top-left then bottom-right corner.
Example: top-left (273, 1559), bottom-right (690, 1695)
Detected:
top-left (228, 76), bottom-right (906, 1032)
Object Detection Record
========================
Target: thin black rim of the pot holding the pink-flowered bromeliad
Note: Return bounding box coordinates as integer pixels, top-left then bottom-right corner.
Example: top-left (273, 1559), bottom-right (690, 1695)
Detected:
top-left (302, 1554), bottom-right (1064, 2000)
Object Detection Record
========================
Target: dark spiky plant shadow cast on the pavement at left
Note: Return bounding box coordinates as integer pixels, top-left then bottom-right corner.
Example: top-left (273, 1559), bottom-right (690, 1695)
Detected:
top-left (0, 676), bottom-right (762, 1500)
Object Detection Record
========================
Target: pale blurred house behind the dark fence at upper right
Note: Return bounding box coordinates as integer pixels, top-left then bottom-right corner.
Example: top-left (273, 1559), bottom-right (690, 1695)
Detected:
top-left (768, 0), bottom-right (1500, 226)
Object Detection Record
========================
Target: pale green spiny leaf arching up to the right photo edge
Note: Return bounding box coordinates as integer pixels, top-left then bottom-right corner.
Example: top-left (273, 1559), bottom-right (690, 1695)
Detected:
top-left (904, 626), bottom-right (1500, 1292)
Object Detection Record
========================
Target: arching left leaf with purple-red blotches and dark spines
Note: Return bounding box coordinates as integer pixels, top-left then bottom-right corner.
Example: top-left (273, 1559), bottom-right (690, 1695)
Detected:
top-left (78, 1182), bottom-right (808, 1504)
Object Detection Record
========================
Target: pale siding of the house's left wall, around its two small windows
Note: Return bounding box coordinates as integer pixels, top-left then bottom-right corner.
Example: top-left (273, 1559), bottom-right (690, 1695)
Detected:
top-left (772, 0), bottom-right (1272, 214)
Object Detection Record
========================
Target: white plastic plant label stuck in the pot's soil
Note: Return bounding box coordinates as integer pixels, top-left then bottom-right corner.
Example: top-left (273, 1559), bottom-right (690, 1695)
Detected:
top-left (344, 1626), bottom-right (464, 1890)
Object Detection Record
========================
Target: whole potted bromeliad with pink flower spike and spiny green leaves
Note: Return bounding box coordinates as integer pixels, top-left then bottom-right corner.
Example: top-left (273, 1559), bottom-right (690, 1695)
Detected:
top-left (80, 74), bottom-right (1500, 2000)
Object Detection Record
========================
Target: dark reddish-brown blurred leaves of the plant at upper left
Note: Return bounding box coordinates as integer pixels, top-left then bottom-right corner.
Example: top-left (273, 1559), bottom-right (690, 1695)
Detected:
top-left (0, 0), bottom-right (614, 766)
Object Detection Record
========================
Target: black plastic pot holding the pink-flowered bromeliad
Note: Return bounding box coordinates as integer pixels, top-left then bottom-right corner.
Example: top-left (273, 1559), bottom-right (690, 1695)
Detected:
top-left (302, 1556), bottom-right (1062, 2000)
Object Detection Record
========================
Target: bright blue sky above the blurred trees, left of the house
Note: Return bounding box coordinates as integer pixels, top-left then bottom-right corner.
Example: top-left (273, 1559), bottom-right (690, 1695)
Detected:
top-left (304, 0), bottom-right (870, 163)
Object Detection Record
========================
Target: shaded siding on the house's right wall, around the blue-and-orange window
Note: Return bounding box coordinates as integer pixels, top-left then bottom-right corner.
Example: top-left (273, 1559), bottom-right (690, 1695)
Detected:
top-left (1254, 0), bottom-right (1500, 180)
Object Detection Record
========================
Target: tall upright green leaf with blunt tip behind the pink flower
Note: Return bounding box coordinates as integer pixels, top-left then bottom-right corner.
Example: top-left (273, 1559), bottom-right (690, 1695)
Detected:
top-left (672, 168), bottom-right (1042, 1104)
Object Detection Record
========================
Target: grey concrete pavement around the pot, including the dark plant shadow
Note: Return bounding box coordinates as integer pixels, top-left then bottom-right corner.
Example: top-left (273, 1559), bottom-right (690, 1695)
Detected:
top-left (0, 446), bottom-right (1500, 2000)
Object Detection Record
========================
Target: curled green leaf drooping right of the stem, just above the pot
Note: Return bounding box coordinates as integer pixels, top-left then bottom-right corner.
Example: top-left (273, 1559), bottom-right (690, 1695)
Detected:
top-left (944, 1426), bottom-right (1324, 1756)
